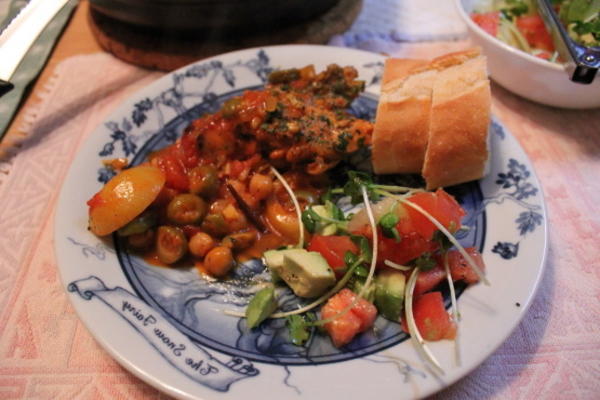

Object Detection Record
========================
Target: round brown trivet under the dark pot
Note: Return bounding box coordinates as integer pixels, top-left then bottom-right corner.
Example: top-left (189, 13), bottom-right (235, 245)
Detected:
top-left (89, 0), bottom-right (363, 71)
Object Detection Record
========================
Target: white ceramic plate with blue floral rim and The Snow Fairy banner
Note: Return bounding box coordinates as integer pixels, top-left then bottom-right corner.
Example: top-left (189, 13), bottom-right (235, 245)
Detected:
top-left (55, 46), bottom-right (547, 400)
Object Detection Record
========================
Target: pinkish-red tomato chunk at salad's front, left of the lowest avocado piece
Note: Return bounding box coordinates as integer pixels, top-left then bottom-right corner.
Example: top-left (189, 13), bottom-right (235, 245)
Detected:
top-left (321, 289), bottom-right (377, 347)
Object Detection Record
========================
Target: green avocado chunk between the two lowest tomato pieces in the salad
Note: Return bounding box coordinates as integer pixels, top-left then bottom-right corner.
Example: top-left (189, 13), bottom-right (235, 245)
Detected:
top-left (375, 270), bottom-right (406, 322)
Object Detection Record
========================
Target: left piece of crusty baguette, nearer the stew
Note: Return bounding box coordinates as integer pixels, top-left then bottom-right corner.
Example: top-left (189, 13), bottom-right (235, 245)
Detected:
top-left (372, 59), bottom-right (435, 174)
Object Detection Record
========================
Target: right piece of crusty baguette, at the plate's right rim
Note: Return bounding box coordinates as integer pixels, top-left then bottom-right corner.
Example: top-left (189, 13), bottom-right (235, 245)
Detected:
top-left (422, 49), bottom-right (491, 190)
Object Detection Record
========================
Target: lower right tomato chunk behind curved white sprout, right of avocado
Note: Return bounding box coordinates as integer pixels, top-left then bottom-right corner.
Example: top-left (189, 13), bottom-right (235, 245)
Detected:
top-left (402, 292), bottom-right (456, 341)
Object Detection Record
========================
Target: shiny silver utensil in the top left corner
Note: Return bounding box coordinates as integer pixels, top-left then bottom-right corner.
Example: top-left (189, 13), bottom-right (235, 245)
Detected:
top-left (0, 0), bottom-right (69, 96)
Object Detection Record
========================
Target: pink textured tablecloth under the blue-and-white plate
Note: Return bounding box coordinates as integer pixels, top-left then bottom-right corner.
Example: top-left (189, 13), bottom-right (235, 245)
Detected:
top-left (0, 44), bottom-right (600, 399)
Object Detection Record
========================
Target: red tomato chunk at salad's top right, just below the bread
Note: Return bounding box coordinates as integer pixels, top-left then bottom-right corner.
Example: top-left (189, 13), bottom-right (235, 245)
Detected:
top-left (406, 189), bottom-right (465, 240)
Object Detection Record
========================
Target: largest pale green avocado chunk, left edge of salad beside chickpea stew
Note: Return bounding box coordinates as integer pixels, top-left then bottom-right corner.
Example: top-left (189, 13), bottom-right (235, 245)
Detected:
top-left (263, 249), bottom-right (335, 297)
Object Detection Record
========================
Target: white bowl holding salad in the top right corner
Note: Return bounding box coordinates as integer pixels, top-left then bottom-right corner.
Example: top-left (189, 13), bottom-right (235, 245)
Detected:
top-left (454, 0), bottom-right (600, 108)
